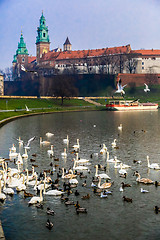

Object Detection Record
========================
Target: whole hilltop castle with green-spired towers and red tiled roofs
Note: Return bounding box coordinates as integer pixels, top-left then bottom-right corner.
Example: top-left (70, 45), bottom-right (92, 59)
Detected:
top-left (12, 12), bottom-right (160, 87)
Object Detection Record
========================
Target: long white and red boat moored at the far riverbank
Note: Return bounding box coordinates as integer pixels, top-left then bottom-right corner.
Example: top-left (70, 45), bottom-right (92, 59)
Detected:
top-left (106, 99), bottom-right (158, 111)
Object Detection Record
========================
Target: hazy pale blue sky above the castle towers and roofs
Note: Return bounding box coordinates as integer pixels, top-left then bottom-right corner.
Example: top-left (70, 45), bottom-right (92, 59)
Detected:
top-left (0, 0), bottom-right (160, 70)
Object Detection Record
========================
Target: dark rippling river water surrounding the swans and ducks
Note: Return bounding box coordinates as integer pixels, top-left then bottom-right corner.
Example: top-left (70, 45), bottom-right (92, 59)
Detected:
top-left (0, 111), bottom-right (160, 240)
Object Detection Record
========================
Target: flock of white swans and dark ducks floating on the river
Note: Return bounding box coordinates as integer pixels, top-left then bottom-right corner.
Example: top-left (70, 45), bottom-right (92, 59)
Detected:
top-left (0, 124), bottom-right (160, 229)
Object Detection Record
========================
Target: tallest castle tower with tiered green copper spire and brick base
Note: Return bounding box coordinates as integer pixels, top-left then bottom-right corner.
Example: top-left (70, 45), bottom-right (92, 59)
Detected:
top-left (36, 12), bottom-right (50, 64)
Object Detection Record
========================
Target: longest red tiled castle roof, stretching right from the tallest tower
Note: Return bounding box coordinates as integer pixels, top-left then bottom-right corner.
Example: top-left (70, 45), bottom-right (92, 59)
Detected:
top-left (41, 45), bottom-right (131, 61)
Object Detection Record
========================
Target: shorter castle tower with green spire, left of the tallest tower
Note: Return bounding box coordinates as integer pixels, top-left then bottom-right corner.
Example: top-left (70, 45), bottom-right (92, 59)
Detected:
top-left (12, 31), bottom-right (28, 67)
